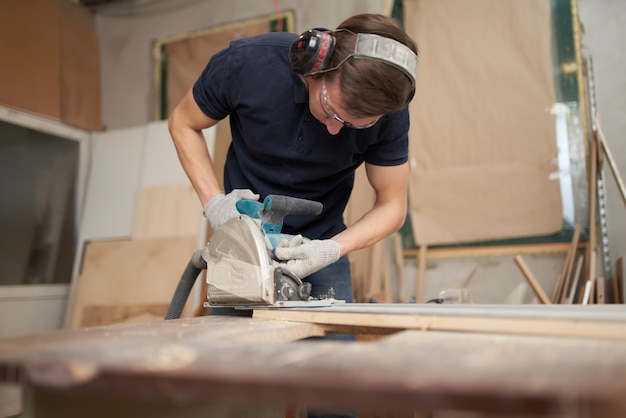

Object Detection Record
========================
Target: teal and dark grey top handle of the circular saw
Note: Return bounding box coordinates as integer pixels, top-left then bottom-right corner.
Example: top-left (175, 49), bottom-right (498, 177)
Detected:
top-left (236, 195), bottom-right (324, 234)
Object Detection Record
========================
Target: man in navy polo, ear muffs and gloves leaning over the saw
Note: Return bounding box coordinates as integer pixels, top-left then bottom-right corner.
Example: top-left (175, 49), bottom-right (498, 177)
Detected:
top-left (169, 14), bottom-right (417, 302)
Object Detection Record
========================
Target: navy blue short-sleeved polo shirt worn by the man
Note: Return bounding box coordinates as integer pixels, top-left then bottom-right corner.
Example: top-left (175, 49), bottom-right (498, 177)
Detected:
top-left (193, 32), bottom-right (409, 239)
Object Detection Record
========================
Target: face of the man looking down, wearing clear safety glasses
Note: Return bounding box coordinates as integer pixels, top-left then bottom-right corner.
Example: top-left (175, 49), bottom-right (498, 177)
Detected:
top-left (309, 77), bottom-right (382, 135)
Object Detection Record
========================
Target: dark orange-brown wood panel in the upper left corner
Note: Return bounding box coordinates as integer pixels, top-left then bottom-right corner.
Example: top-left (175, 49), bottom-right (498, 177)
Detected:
top-left (0, 0), bottom-right (102, 130)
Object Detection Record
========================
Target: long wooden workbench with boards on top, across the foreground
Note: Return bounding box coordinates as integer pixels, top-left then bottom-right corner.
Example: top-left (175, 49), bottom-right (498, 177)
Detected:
top-left (0, 304), bottom-right (626, 418)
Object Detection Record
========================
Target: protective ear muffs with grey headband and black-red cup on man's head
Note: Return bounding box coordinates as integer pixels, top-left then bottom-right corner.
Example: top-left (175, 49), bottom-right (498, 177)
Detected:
top-left (289, 29), bottom-right (419, 101)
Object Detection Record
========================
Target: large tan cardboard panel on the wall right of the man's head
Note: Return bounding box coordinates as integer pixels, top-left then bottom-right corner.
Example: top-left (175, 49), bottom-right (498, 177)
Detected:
top-left (404, 0), bottom-right (562, 245)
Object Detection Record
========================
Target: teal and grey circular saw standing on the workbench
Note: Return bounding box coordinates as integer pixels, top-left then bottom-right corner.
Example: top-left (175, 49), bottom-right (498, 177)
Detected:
top-left (202, 195), bottom-right (339, 307)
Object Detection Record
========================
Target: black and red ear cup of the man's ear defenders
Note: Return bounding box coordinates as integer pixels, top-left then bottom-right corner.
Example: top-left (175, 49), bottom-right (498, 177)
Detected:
top-left (289, 29), bottom-right (335, 75)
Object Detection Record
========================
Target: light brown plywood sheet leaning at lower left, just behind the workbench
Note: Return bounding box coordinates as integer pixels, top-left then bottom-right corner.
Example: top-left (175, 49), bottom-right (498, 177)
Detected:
top-left (68, 237), bottom-right (196, 328)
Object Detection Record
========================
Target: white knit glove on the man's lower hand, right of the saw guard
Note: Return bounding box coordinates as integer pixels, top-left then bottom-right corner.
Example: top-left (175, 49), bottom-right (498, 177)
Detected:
top-left (274, 235), bottom-right (340, 279)
